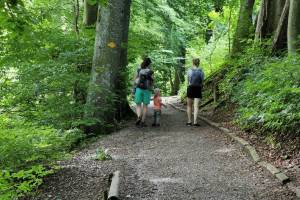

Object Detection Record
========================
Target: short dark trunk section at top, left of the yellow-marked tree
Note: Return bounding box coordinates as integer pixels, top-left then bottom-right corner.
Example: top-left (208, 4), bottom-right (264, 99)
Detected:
top-left (83, 0), bottom-right (98, 26)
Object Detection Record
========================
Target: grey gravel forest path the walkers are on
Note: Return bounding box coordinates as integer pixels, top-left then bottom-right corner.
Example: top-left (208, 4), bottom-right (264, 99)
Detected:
top-left (31, 98), bottom-right (294, 200)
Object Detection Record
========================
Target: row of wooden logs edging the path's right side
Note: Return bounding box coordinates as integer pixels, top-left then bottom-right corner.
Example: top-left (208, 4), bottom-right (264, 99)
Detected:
top-left (168, 102), bottom-right (300, 198)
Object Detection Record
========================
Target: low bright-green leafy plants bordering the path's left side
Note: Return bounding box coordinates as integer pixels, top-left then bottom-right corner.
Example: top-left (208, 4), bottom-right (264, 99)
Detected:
top-left (0, 115), bottom-right (83, 199)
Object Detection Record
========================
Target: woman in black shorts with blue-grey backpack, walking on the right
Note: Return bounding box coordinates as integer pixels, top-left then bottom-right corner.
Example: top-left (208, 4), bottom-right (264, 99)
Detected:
top-left (186, 58), bottom-right (204, 126)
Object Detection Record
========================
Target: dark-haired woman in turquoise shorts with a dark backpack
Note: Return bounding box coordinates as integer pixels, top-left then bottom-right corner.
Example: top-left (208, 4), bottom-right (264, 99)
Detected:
top-left (134, 57), bottom-right (153, 127)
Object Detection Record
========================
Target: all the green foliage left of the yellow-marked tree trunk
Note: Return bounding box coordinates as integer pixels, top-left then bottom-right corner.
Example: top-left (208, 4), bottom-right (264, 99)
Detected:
top-left (0, 0), bottom-right (94, 199)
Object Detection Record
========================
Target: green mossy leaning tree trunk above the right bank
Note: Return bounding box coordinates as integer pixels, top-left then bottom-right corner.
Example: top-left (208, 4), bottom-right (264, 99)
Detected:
top-left (232, 0), bottom-right (255, 55)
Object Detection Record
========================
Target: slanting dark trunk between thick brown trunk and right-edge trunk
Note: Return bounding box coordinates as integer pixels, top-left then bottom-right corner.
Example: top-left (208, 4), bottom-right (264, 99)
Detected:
top-left (272, 0), bottom-right (290, 52)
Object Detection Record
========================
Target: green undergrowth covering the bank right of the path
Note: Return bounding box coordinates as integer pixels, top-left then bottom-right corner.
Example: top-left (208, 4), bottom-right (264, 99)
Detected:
top-left (220, 44), bottom-right (300, 149)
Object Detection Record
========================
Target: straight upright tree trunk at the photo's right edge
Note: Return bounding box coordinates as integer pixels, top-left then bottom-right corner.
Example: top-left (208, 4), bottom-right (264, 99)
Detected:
top-left (288, 0), bottom-right (300, 55)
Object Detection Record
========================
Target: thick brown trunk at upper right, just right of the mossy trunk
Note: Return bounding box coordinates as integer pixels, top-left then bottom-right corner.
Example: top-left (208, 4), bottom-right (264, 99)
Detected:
top-left (255, 0), bottom-right (286, 40)
